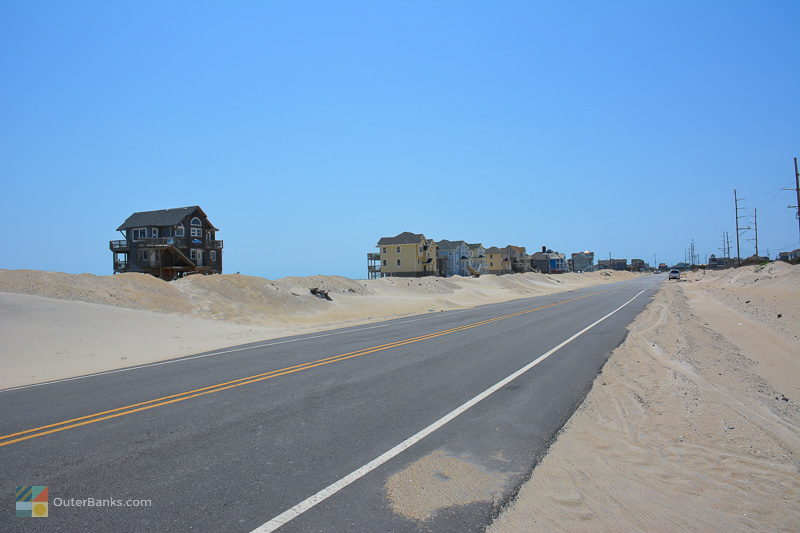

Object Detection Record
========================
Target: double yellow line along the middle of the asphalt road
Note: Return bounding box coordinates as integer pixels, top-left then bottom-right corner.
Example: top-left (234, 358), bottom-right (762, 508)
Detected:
top-left (0, 290), bottom-right (608, 447)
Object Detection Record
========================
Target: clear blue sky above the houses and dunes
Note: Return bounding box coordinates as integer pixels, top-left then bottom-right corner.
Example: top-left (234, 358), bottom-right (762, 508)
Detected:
top-left (0, 1), bottom-right (800, 278)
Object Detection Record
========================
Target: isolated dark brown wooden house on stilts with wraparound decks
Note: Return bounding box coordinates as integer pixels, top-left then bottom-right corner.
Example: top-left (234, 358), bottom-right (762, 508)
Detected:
top-left (108, 205), bottom-right (222, 281)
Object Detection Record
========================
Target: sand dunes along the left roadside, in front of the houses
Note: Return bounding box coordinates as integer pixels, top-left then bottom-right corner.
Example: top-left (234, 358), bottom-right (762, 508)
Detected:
top-left (0, 270), bottom-right (637, 388)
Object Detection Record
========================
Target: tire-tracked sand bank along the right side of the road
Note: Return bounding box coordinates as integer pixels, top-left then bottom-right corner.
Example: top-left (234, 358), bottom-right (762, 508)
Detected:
top-left (489, 263), bottom-right (800, 533)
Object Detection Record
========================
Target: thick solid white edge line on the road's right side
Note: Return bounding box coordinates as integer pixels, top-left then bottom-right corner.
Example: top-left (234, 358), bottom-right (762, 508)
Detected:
top-left (252, 290), bottom-right (644, 533)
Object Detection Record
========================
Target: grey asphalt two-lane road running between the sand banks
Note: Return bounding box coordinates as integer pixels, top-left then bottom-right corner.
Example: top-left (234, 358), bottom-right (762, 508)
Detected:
top-left (0, 276), bottom-right (663, 532)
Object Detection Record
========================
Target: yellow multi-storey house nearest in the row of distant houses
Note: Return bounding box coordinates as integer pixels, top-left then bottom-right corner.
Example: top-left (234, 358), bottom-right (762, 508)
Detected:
top-left (376, 231), bottom-right (439, 278)
